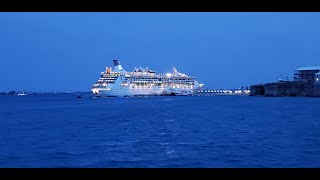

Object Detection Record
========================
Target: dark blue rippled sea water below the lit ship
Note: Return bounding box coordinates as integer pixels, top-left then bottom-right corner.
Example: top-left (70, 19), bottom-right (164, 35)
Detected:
top-left (0, 95), bottom-right (320, 167)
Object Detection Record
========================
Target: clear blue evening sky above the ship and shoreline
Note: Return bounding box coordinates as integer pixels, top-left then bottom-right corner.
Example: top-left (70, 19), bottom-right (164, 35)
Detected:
top-left (0, 12), bottom-right (320, 91)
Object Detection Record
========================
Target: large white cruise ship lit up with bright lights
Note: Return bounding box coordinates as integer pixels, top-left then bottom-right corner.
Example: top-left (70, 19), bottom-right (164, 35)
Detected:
top-left (91, 60), bottom-right (204, 97)
